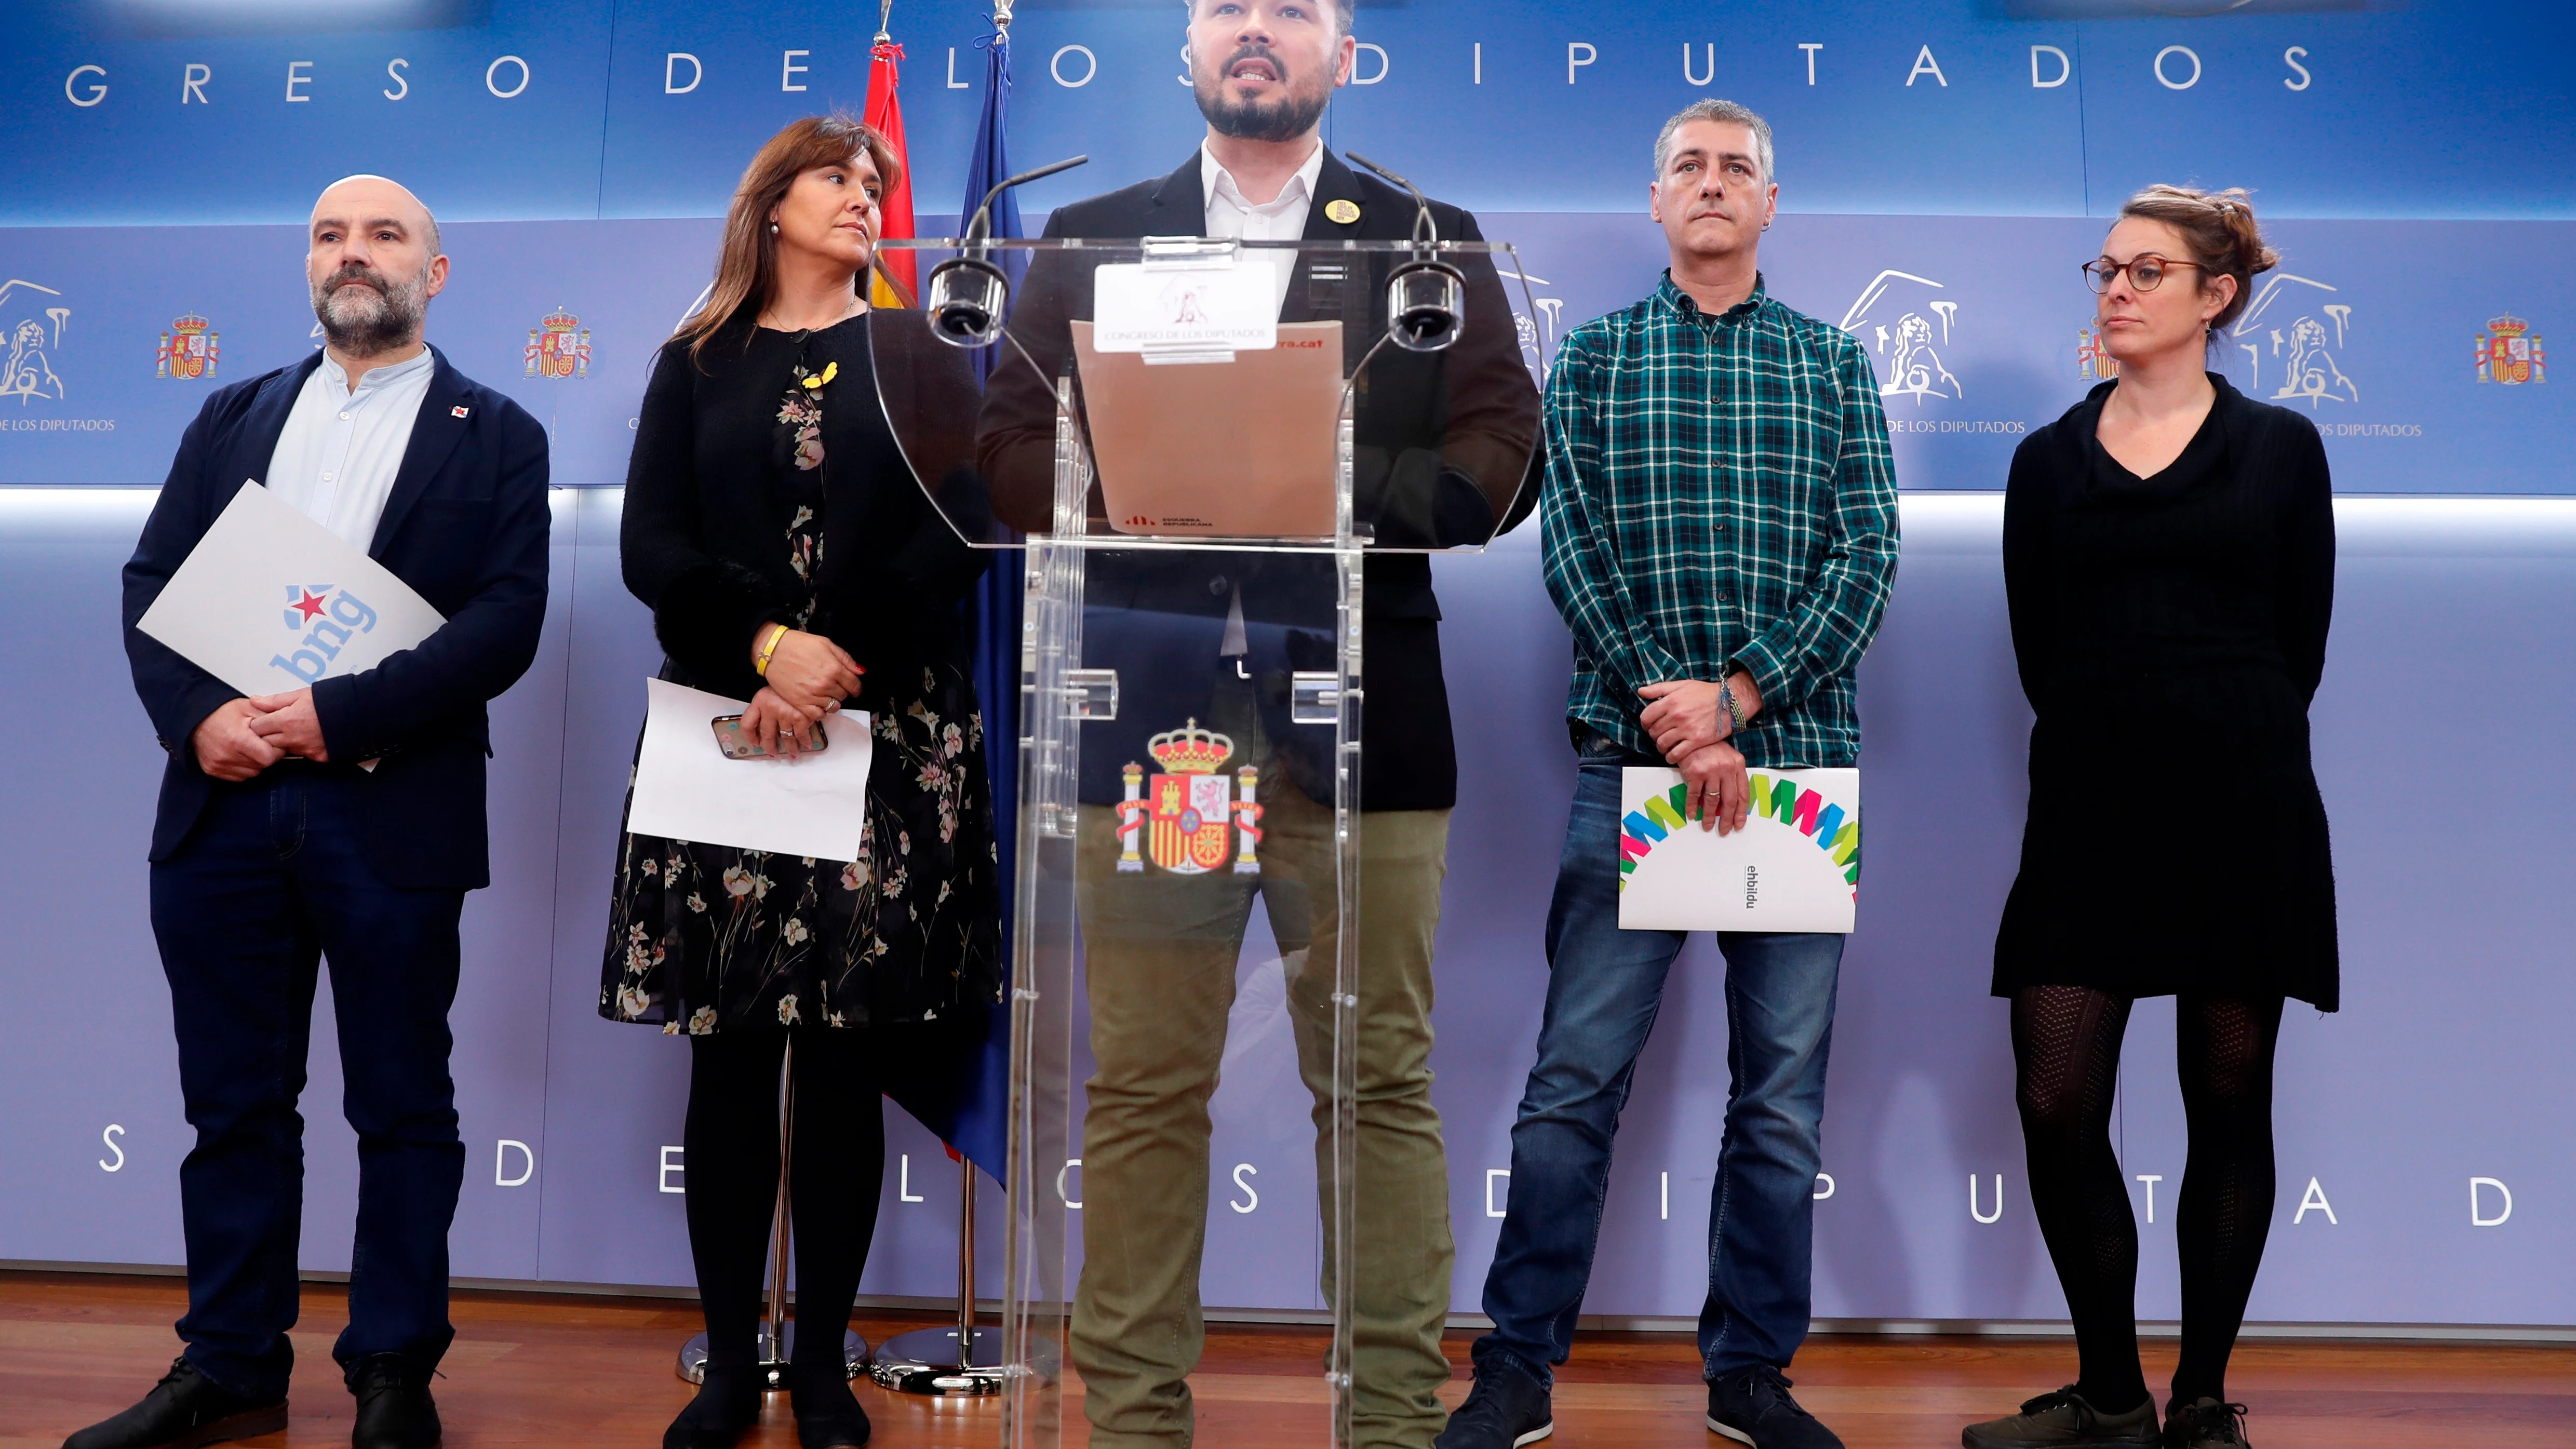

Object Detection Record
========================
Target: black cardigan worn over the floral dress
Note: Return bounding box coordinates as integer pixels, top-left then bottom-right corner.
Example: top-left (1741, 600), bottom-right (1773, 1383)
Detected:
top-left (618, 317), bottom-right (987, 709)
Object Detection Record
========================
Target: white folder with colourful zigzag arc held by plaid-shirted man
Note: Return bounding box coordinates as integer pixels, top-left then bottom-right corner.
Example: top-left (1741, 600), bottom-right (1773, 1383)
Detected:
top-left (1618, 766), bottom-right (1860, 936)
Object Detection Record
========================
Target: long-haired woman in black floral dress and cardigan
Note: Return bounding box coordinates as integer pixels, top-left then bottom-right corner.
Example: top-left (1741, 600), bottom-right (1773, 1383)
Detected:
top-left (600, 116), bottom-right (1002, 1449)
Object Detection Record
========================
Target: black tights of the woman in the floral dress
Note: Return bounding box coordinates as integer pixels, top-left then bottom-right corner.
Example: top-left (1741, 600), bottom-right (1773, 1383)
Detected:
top-left (682, 1026), bottom-right (886, 1369)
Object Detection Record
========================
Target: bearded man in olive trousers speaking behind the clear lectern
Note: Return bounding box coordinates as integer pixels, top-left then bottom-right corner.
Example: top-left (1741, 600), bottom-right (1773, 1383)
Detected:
top-left (979, 0), bottom-right (1538, 1449)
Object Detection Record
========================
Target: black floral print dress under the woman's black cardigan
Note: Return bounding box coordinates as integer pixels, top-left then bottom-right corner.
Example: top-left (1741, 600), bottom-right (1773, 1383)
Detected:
top-left (600, 321), bottom-right (997, 1037)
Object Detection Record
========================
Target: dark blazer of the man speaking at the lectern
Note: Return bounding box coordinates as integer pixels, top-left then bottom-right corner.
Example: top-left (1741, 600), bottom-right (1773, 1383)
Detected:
top-left (982, 150), bottom-right (1538, 810)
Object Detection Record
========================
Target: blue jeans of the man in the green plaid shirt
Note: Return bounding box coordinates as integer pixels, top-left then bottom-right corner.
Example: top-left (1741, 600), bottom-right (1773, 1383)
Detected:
top-left (1476, 735), bottom-right (1842, 1385)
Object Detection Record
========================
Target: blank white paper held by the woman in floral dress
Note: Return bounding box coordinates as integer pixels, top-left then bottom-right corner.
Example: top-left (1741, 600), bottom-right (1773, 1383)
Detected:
top-left (626, 678), bottom-right (870, 861)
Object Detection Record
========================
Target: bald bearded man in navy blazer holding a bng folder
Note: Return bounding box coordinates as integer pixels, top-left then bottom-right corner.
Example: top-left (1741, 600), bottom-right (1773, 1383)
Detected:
top-left (89, 176), bottom-right (548, 1449)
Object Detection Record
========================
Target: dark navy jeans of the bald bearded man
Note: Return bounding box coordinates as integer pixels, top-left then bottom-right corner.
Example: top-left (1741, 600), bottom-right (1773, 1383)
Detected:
top-left (152, 763), bottom-right (466, 1400)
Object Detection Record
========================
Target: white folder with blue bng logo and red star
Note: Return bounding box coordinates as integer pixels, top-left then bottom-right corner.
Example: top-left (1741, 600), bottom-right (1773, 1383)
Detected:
top-left (137, 482), bottom-right (448, 693)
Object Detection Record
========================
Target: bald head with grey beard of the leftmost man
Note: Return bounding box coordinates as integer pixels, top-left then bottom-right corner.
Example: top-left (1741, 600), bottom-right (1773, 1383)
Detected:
top-left (304, 176), bottom-right (448, 366)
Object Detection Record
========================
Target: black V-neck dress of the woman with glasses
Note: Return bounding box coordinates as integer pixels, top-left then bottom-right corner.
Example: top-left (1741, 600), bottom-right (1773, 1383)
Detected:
top-left (1994, 374), bottom-right (2339, 1011)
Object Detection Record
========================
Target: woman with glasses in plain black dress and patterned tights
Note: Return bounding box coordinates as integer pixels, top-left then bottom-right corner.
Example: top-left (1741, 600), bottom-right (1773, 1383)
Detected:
top-left (1963, 185), bottom-right (2337, 1449)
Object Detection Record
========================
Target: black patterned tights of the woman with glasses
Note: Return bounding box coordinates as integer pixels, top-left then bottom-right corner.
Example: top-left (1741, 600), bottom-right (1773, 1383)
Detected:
top-left (2012, 985), bottom-right (2283, 1413)
